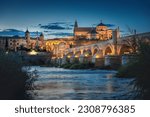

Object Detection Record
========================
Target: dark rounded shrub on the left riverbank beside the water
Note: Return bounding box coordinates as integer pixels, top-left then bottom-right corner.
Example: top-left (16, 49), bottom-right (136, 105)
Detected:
top-left (0, 51), bottom-right (29, 99)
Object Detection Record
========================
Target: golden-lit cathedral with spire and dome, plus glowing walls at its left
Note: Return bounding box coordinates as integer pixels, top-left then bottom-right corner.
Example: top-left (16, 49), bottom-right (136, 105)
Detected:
top-left (46, 21), bottom-right (113, 58)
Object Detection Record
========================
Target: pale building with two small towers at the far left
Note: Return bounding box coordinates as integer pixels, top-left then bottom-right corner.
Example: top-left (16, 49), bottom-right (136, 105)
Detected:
top-left (0, 29), bottom-right (45, 51)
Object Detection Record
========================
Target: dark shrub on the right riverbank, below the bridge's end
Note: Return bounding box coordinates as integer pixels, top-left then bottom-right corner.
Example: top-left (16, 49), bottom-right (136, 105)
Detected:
top-left (117, 42), bottom-right (150, 99)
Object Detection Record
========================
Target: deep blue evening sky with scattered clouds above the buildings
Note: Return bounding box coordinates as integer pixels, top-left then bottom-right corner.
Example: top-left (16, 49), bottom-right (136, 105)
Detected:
top-left (0, 0), bottom-right (150, 39)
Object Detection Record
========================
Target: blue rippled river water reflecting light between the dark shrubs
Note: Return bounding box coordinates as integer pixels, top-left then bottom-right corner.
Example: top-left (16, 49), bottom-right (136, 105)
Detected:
top-left (27, 66), bottom-right (134, 100)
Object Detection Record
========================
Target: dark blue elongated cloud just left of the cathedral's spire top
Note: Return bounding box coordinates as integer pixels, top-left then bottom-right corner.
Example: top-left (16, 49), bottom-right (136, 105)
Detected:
top-left (38, 22), bottom-right (73, 30)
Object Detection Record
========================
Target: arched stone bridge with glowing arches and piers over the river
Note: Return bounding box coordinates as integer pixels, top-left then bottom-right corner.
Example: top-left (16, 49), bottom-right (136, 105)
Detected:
top-left (53, 31), bottom-right (150, 66)
